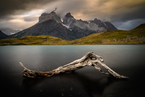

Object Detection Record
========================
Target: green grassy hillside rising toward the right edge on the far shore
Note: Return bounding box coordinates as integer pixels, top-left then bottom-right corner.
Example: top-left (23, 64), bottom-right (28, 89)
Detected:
top-left (70, 24), bottom-right (145, 44)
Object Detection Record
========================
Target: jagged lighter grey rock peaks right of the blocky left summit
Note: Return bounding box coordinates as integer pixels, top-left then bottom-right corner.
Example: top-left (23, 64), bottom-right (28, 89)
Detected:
top-left (63, 13), bottom-right (116, 32)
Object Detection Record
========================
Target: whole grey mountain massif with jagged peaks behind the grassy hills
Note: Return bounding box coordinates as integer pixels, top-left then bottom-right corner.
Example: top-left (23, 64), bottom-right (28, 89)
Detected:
top-left (10, 11), bottom-right (116, 40)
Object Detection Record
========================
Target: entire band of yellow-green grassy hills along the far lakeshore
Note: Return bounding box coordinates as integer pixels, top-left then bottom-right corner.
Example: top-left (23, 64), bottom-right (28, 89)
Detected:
top-left (0, 24), bottom-right (145, 45)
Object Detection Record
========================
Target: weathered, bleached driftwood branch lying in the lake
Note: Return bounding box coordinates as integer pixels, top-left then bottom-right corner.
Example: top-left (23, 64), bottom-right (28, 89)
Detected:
top-left (20, 52), bottom-right (128, 78)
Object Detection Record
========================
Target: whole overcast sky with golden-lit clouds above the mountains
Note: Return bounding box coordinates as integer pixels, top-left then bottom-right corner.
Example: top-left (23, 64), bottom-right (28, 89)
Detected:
top-left (0, 0), bottom-right (145, 30)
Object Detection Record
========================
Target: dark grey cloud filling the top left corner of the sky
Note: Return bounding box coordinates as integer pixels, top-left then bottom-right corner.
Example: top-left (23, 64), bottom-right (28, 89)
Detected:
top-left (0, 0), bottom-right (55, 18)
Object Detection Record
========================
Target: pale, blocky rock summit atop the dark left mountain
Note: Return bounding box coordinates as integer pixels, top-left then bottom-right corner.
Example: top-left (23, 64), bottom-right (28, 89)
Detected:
top-left (38, 11), bottom-right (61, 23)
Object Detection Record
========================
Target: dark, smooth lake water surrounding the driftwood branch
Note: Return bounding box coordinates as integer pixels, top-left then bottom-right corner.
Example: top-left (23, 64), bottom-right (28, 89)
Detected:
top-left (0, 45), bottom-right (145, 97)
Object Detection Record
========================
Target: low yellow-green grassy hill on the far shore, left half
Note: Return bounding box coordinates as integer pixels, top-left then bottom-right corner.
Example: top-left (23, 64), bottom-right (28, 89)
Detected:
top-left (0, 35), bottom-right (67, 45)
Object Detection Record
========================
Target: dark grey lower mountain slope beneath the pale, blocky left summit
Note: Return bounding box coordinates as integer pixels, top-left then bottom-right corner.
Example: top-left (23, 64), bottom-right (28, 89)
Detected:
top-left (11, 19), bottom-right (76, 40)
